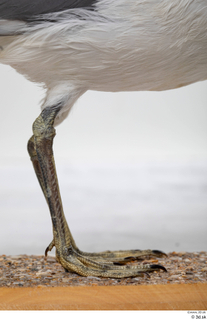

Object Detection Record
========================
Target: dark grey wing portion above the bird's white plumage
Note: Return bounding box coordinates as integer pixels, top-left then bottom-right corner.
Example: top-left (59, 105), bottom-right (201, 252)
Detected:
top-left (0, 0), bottom-right (98, 21)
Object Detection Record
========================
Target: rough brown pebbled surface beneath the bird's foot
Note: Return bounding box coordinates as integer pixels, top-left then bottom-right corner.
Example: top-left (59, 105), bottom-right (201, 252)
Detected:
top-left (0, 251), bottom-right (207, 288)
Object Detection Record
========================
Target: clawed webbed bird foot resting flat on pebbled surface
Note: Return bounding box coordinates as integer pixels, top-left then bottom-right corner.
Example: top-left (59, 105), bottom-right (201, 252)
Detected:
top-left (45, 241), bottom-right (167, 278)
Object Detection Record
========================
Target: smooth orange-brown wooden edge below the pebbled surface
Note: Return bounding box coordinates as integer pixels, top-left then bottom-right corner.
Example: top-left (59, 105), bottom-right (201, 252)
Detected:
top-left (0, 283), bottom-right (207, 310)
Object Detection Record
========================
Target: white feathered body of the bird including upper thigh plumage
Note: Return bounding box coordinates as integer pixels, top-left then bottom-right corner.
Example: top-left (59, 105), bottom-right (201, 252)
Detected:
top-left (0, 0), bottom-right (207, 122)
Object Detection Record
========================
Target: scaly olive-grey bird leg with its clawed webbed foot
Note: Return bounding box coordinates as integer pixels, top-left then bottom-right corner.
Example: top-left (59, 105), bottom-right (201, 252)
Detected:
top-left (28, 106), bottom-right (166, 278)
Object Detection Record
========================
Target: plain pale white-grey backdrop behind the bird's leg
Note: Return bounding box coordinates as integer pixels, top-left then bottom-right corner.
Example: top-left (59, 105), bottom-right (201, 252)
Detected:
top-left (0, 65), bottom-right (207, 254)
